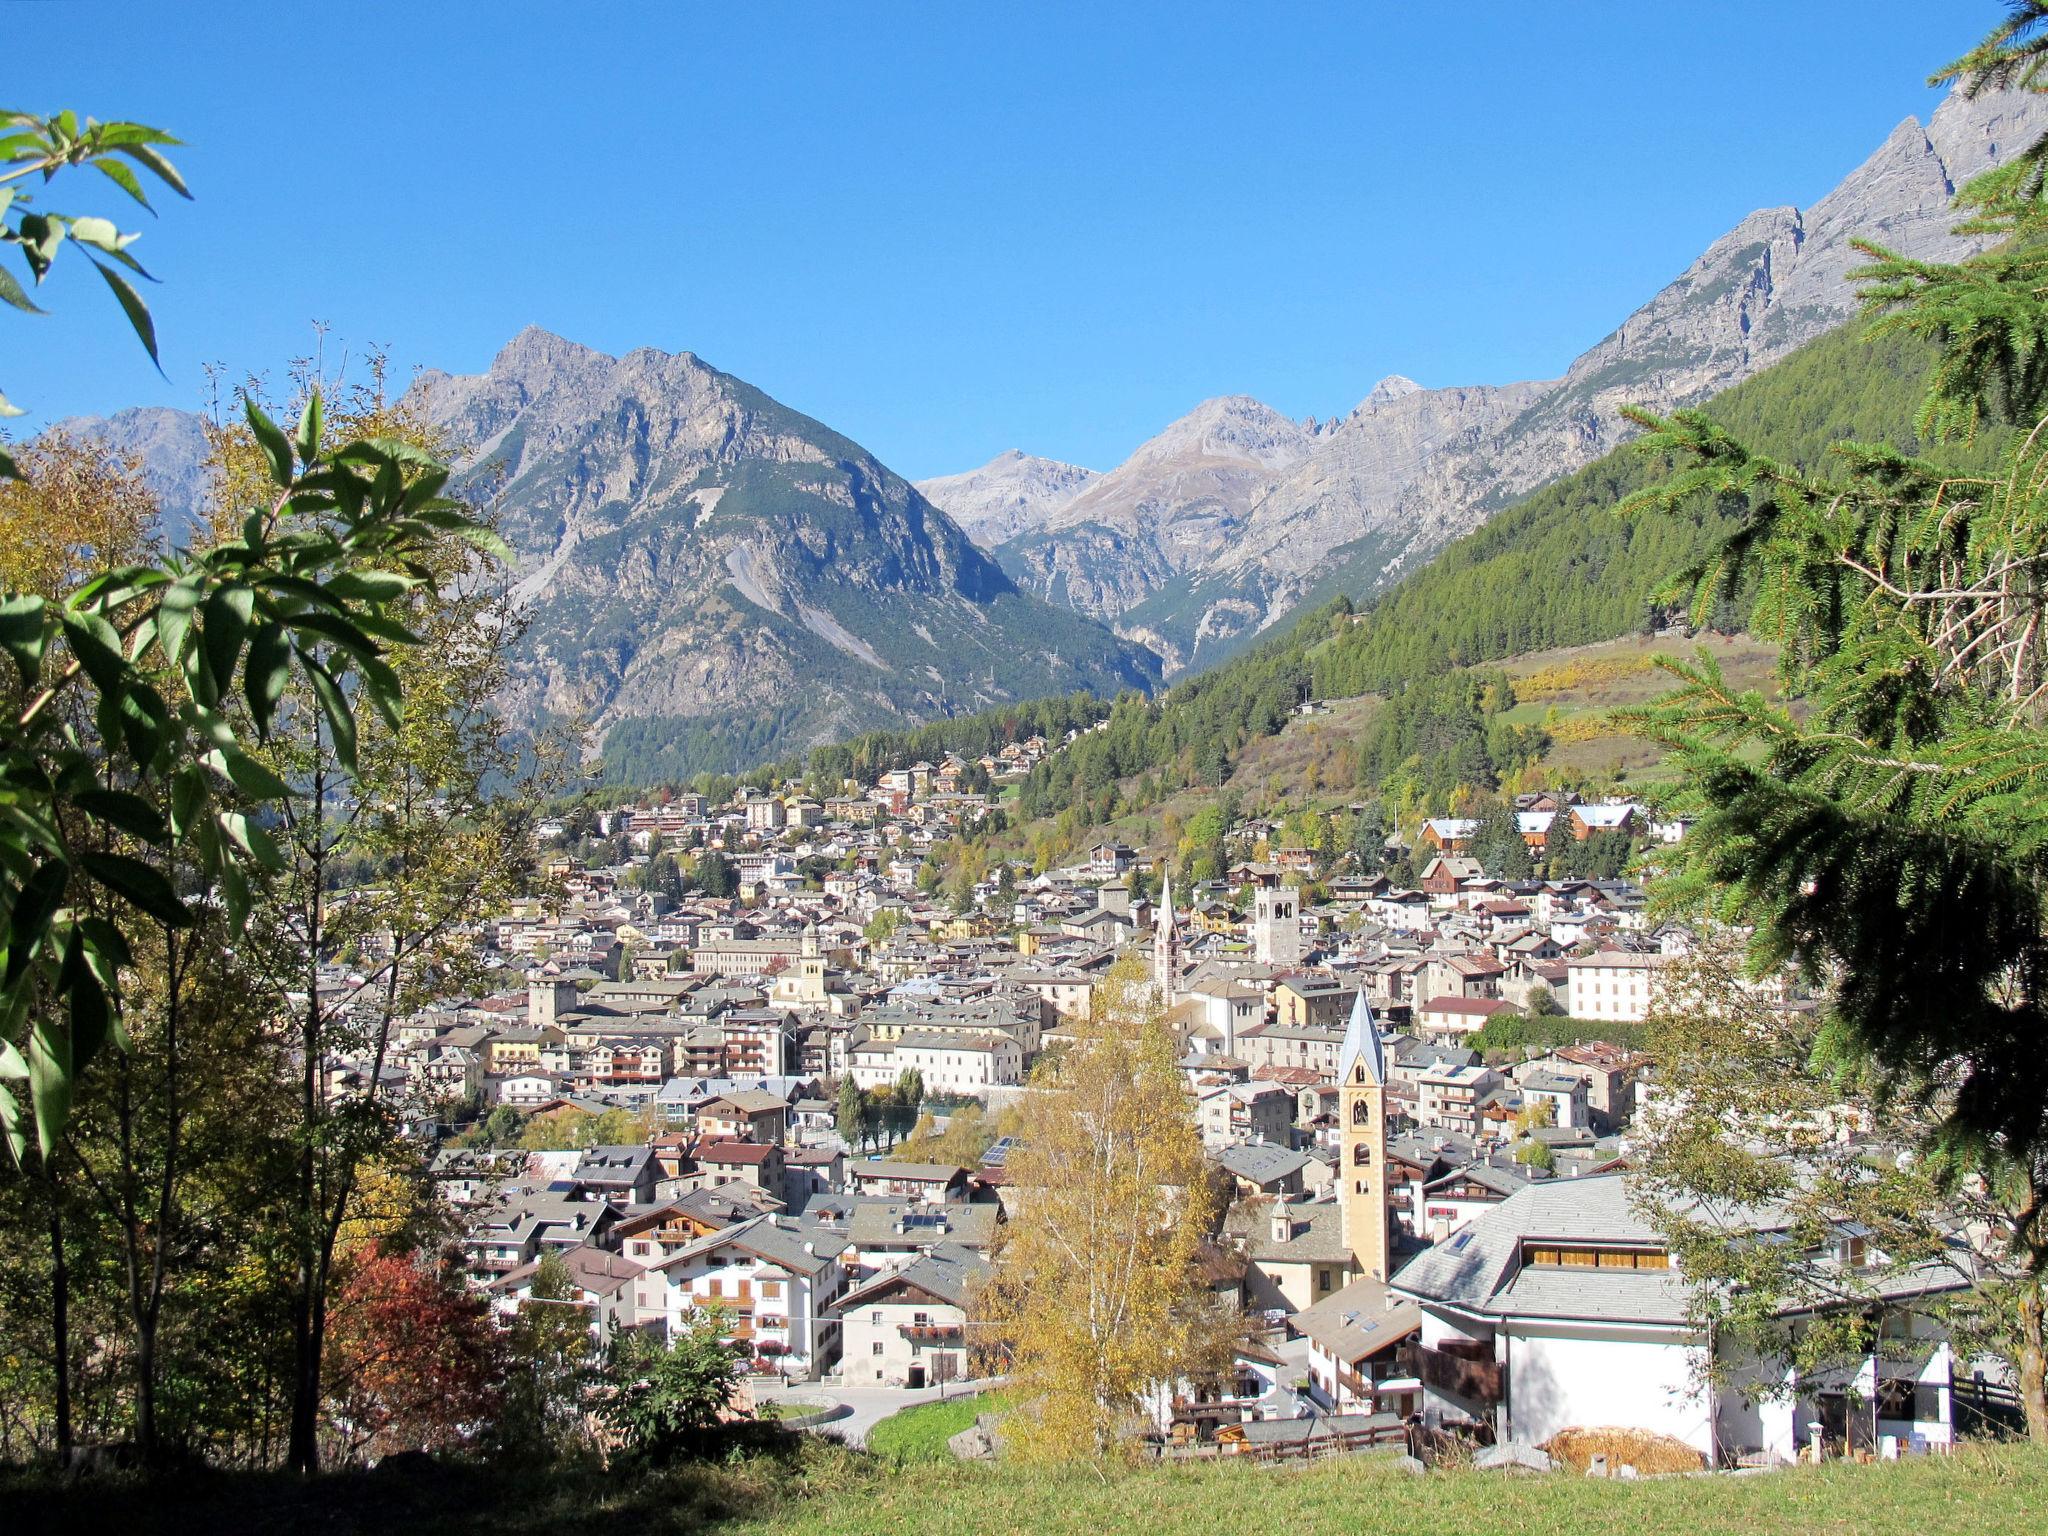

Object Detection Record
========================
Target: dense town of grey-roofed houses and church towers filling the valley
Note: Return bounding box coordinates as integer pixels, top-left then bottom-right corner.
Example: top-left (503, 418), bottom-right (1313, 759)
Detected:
top-left (330, 762), bottom-right (1954, 1462)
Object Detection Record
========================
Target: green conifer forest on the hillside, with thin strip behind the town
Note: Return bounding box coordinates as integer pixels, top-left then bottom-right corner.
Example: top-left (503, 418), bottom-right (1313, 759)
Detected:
top-left (643, 315), bottom-right (1999, 843)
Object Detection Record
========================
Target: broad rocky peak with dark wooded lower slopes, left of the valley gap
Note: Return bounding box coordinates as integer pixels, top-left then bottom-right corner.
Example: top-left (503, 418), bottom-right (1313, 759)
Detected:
top-left (410, 330), bottom-right (1157, 776)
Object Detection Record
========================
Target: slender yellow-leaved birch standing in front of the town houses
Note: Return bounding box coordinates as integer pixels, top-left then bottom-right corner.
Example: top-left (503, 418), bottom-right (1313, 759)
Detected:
top-left (979, 958), bottom-right (1214, 1460)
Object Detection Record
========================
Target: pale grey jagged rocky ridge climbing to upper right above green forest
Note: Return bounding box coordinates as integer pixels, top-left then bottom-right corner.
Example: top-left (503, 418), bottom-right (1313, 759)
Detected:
top-left (933, 82), bottom-right (2048, 672)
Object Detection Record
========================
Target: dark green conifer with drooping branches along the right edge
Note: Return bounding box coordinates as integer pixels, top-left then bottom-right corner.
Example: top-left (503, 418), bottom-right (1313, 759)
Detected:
top-left (1624, 0), bottom-right (2048, 1436)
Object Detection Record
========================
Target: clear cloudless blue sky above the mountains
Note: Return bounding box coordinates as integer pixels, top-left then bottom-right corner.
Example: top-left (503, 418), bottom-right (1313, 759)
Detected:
top-left (0, 0), bottom-right (1997, 477)
